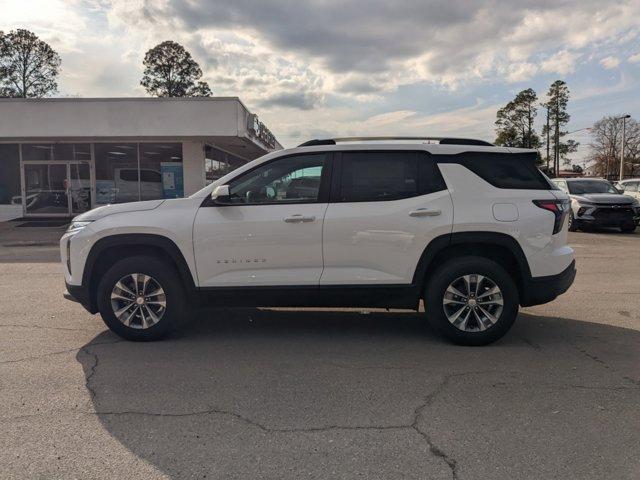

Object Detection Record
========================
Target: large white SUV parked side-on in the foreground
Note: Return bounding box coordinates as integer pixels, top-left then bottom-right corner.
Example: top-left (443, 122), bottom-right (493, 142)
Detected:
top-left (60, 137), bottom-right (575, 345)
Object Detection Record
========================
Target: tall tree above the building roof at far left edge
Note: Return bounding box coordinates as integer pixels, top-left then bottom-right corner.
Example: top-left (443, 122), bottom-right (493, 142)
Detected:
top-left (0, 29), bottom-right (61, 98)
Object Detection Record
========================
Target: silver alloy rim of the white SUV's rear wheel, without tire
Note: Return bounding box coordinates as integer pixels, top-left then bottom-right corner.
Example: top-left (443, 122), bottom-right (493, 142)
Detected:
top-left (442, 273), bottom-right (504, 332)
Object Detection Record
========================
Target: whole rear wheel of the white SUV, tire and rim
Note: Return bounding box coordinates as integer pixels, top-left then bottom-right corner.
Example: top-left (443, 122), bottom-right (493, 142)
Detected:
top-left (424, 256), bottom-right (519, 346)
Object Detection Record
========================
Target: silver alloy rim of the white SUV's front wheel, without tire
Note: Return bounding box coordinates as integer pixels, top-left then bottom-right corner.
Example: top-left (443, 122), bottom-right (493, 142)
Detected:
top-left (111, 273), bottom-right (167, 330)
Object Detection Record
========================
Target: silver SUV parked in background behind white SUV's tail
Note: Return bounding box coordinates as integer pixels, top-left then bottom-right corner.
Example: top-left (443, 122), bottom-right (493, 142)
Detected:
top-left (553, 178), bottom-right (640, 233)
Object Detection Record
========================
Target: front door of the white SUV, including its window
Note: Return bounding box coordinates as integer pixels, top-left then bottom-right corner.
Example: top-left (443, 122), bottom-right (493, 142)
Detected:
top-left (193, 153), bottom-right (330, 287)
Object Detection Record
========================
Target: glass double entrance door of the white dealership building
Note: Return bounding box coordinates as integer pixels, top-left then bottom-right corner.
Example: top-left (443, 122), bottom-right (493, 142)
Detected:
top-left (23, 162), bottom-right (91, 217)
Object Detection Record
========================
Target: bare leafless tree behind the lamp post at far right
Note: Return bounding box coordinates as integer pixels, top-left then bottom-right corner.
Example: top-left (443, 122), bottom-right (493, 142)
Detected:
top-left (589, 117), bottom-right (640, 178)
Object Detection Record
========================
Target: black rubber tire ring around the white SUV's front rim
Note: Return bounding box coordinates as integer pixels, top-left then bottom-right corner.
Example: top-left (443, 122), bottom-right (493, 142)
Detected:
top-left (97, 256), bottom-right (187, 341)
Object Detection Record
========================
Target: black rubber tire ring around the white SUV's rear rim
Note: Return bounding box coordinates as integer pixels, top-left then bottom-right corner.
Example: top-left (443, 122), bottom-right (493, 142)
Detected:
top-left (424, 256), bottom-right (519, 346)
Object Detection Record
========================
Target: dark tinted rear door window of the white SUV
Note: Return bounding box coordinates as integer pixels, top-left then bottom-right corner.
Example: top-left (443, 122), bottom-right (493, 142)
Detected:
top-left (338, 151), bottom-right (446, 202)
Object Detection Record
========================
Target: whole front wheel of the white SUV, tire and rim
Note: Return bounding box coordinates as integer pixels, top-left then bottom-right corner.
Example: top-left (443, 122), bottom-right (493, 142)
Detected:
top-left (97, 256), bottom-right (189, 341)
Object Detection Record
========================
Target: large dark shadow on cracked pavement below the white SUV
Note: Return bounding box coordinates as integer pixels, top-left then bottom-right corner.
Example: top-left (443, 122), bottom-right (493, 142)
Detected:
top-left (76, 309), bottom-right (640, 479)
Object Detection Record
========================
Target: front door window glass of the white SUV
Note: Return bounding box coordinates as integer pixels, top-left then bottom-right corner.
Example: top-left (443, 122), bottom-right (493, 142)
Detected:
top-left (229, 154), bottom-right (326, 205)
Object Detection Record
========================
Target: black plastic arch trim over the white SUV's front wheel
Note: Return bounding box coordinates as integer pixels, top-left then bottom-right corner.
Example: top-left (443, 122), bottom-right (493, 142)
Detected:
top-left (82, 233), bottom-right (196, 313)
